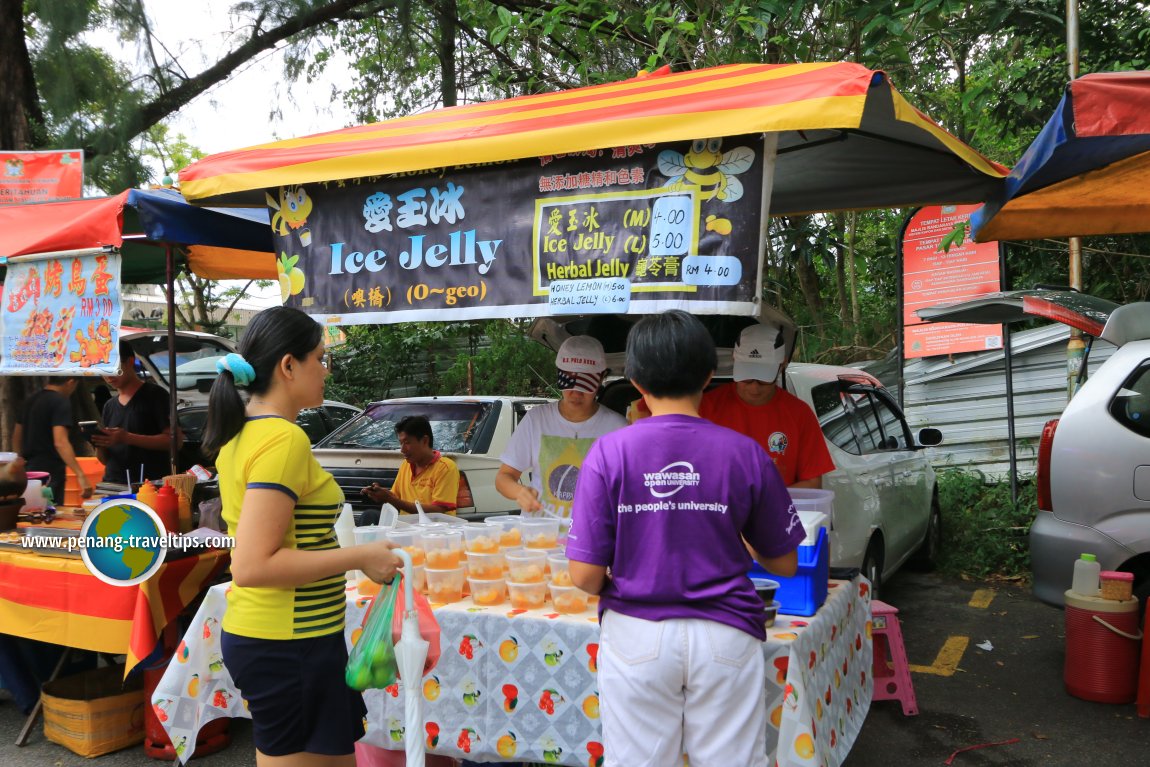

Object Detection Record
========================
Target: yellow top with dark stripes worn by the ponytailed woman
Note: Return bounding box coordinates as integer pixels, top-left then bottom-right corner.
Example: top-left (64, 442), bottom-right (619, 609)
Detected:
top-left (216, 416), bottom-right (346, 639)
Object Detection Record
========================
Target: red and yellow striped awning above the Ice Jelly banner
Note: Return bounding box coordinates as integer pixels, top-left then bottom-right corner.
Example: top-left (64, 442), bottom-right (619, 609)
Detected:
top-left (179, 62), bottom-right (1006, 214)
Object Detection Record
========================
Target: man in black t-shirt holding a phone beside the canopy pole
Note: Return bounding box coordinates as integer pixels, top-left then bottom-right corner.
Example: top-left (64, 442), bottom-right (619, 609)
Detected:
top-left (92, 340), bottom-right (178, 484)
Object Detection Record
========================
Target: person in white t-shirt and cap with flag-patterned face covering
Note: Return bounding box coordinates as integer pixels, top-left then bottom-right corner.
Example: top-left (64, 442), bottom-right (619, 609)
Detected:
top-left (496, 336), bottom-right (627, 519)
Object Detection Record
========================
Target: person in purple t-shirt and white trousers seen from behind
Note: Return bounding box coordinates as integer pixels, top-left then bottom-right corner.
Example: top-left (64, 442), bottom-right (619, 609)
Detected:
top-left (567, 310), bottom-right (804, 767)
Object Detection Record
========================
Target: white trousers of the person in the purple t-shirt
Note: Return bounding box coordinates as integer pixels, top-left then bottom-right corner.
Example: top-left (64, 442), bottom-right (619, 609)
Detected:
top-left (599, 611), bottom-right (767, 767)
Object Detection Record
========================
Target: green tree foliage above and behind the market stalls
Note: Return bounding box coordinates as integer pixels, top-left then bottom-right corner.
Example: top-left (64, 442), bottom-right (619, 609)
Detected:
top-left (0, 0), bottom-right (1150, 400)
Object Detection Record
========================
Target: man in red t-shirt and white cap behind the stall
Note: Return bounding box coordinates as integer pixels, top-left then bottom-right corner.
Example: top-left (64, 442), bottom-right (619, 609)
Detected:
top-left (699, 322), bottom-right (835, 488)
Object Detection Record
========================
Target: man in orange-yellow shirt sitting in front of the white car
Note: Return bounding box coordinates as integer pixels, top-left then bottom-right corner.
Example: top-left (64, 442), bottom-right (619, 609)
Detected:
top-left (360, 415), bottom-right (459, 524)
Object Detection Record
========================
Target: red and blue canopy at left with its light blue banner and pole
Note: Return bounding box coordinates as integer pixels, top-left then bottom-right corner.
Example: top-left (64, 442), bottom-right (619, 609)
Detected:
top-left (0, 189), bottom-right (277, 468)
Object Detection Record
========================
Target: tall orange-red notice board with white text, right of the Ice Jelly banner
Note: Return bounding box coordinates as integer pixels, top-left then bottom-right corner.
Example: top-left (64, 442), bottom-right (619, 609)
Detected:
top-left (902, 205), bottom-right (1003, 359)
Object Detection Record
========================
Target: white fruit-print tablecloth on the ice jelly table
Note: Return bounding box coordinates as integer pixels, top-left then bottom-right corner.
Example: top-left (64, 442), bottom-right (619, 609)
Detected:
top-left (152, 577), bottom-right (872, 767)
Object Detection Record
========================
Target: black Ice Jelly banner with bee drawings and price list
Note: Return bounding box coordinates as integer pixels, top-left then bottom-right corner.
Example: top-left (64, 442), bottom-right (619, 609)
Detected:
top-left (268, 136), bottom-right (774, 324)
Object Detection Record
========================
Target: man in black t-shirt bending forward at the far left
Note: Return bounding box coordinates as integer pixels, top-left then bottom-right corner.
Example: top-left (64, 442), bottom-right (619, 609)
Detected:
top-left (12, 376), bottom-right (92, 505)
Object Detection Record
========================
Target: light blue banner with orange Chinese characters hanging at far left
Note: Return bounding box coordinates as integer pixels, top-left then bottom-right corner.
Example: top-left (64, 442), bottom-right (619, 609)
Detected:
top-left (0, 252), bottom-right (123, 375)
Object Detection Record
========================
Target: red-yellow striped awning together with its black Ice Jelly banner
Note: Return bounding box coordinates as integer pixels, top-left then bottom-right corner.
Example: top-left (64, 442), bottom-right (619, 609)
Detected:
top-left (179, 62), bottom-right (1006, 324)
